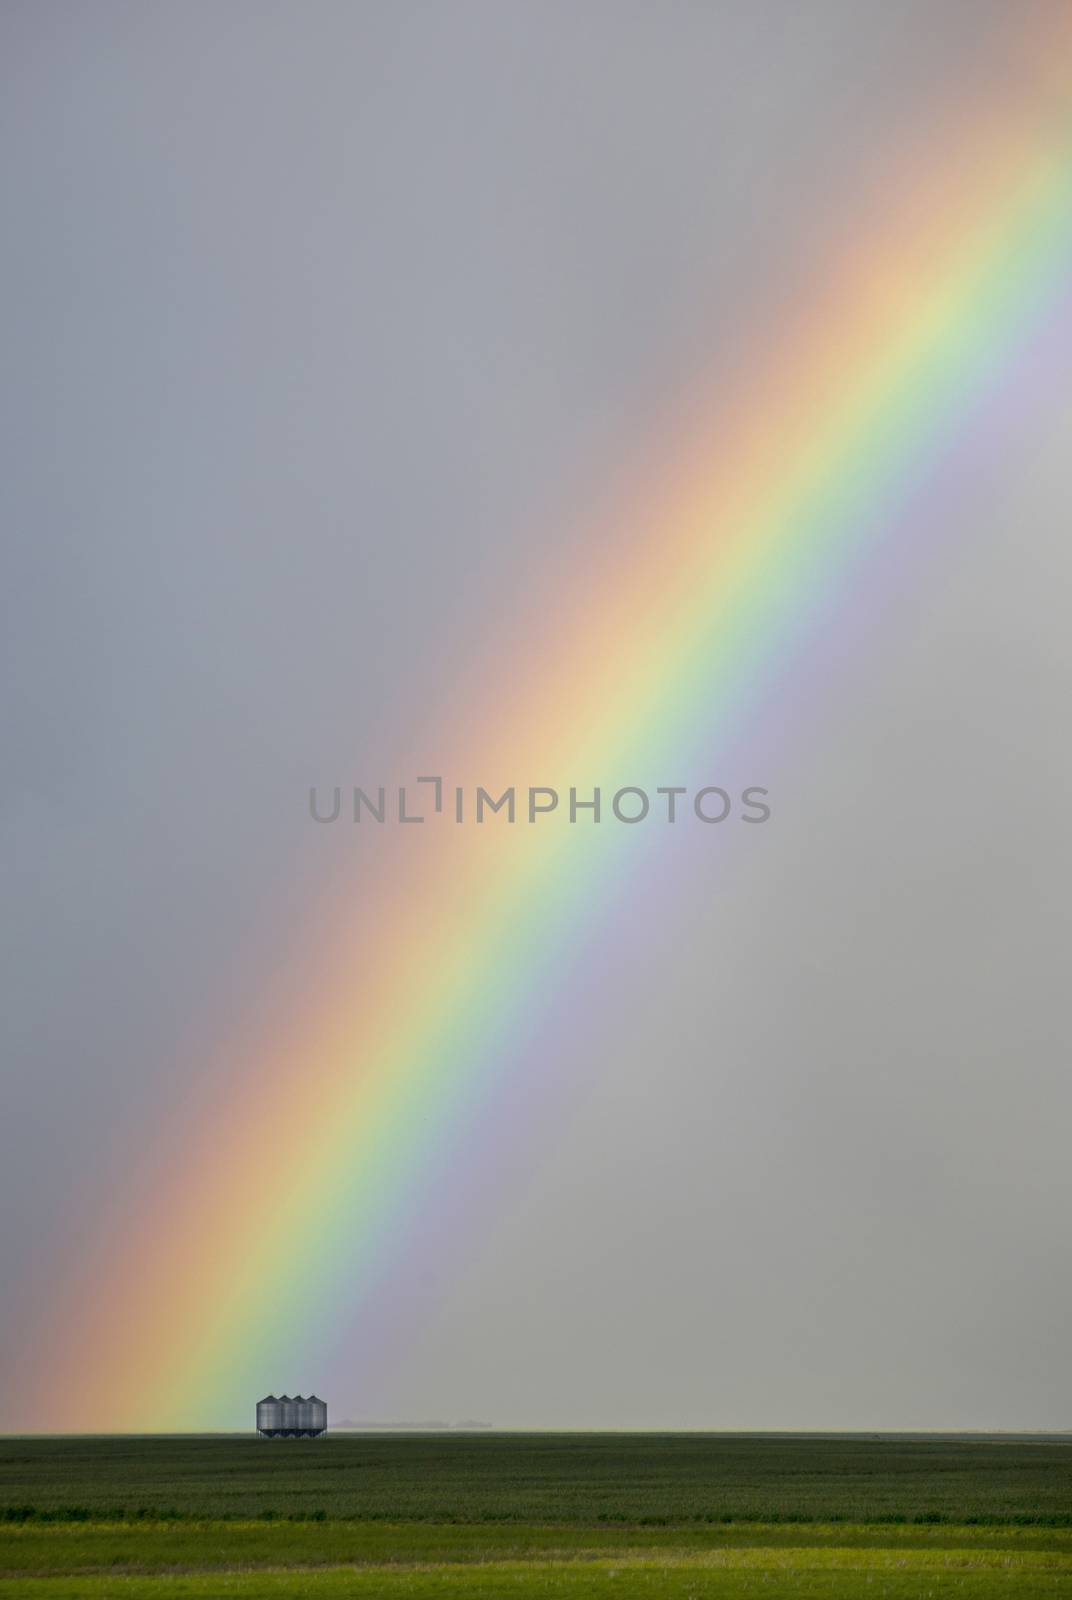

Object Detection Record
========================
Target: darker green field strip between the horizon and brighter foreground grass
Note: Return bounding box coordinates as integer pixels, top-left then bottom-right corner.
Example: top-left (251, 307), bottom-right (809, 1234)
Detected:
top-left (0, 1434), bottom-right (1072, 1525)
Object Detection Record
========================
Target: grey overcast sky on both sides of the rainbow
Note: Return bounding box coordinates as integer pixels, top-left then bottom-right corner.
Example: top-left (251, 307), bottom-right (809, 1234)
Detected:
top-left (0, 0), bottom-right (1072, 1427)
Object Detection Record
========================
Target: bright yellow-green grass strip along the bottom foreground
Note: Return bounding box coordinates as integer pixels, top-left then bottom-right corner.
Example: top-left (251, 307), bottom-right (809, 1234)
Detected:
top-left (0, 1522), bottom-right (1072, 1600)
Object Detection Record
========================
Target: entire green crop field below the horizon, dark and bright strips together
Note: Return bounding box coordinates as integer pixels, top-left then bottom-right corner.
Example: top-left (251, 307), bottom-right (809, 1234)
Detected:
top-left (0, 1434), bottom-right (1072, 1600)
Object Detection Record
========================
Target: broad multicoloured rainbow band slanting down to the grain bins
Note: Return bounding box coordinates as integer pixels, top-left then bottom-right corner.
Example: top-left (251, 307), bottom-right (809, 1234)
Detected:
top-left (26, 18), bottom-right (1072, 1430)
